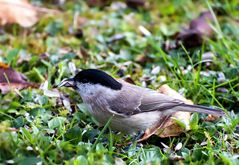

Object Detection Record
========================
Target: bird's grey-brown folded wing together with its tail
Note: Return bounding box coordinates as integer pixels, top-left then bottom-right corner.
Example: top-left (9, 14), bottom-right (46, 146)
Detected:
top-left (109, 81), bottom-right (225, 116)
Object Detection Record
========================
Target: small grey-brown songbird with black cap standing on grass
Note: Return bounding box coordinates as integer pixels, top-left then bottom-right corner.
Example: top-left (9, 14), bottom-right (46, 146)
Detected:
top-left (58, 69), bottom-right (224, 134)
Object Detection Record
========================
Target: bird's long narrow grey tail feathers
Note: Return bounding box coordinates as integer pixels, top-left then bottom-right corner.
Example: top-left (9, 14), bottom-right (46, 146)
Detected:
top-left (176, 104), bottom-right (225, 116)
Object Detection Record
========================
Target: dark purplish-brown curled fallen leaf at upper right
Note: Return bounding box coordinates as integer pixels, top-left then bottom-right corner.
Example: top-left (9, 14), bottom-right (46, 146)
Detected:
top-left (176, 11), bottom-right (213, 48)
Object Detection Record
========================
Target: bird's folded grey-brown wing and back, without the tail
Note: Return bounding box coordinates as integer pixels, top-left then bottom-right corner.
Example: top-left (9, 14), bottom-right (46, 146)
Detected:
top-left (109, 81), bottom-right (183, 116)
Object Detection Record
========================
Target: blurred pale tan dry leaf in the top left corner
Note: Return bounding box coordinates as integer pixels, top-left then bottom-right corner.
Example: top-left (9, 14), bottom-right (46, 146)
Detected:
top-left (0, 0), bottom-right (38, 27)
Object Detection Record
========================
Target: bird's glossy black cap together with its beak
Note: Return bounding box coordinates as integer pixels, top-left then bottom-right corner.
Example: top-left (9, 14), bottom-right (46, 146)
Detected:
top-left (58, 69), bottom-right (122, 90)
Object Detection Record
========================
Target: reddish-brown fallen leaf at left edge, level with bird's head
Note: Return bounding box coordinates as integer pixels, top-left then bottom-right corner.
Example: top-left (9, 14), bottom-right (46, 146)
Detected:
top-left (0, 63), bottom-right (37, 94)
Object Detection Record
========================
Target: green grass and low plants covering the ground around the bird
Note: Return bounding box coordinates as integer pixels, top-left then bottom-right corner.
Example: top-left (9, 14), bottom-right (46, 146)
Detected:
top-left (0, 0), bottom-right (239, 165)
